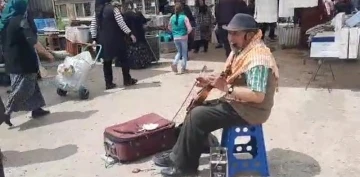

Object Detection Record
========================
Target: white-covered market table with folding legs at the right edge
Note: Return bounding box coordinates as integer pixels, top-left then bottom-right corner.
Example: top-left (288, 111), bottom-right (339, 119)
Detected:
top-left (306, 12), bottom-right (360, 91)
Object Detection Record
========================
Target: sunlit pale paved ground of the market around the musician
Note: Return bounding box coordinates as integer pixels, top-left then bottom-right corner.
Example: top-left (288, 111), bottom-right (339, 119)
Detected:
top-left (0, 44), bottom-right (360, 177)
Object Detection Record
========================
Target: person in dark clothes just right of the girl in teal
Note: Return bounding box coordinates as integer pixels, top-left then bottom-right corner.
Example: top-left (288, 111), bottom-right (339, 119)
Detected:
top-left (194, 0), bottom-right (213, 53)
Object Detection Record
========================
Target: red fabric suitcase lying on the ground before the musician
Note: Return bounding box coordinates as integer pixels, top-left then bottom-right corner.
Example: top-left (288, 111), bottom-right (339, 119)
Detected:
top-left (104, 113), bottom-right (176, 162)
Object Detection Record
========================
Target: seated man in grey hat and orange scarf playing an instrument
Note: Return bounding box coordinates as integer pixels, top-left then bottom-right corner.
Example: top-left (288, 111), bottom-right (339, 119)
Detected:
top-left (155, 13), bottom-right (279, 176)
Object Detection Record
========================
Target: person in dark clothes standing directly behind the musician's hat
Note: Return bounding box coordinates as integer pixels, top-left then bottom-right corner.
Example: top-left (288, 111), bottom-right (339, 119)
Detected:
top-left (215, 0), bottom-right (250, 57)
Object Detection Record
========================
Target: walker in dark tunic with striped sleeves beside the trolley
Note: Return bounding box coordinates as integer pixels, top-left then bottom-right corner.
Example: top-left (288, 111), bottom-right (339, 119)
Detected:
top-left (90, 0), bottom-right (137, 89)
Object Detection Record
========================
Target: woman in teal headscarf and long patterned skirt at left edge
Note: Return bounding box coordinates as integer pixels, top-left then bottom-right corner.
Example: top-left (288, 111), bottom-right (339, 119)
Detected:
top-left (0, 0), bottom-right (50, 126)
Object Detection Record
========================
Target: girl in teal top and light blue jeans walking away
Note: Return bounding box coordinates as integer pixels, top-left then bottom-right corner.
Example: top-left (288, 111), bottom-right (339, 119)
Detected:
top-left (168, 3), bottom-right (192, 74)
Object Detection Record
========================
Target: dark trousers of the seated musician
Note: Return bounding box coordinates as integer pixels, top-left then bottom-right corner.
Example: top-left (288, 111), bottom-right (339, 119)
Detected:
top-left (170, 100), bottom-right (247, 170)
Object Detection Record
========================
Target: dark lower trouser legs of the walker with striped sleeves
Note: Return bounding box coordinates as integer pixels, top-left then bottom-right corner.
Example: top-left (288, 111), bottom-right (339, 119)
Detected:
top-left (103, 60), bottom-right (131, 85)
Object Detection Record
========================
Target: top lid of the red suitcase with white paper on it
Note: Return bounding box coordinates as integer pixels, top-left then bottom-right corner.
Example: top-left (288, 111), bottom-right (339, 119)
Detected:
top-left (105, 113), bottom-right (175, 139)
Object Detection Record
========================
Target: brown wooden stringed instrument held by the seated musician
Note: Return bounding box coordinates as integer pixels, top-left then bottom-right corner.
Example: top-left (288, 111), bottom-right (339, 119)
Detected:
top-left (186, 62), bottom-right (233, 112)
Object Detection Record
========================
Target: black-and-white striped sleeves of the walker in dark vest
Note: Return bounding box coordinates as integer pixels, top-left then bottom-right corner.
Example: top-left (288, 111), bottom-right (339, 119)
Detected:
top-left (90, 7), bottom-right (131, 39)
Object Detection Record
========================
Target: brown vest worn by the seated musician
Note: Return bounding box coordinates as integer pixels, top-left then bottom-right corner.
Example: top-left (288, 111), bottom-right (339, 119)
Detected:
top-left (224, 71), bottom-right (276, 125)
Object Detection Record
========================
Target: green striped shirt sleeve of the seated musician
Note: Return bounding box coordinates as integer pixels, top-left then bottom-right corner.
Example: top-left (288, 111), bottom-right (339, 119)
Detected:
top-left (245, 65), bottom-right (269, 93)
